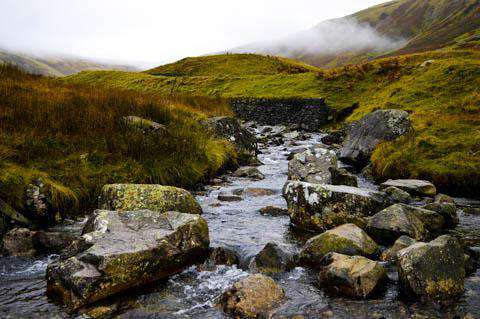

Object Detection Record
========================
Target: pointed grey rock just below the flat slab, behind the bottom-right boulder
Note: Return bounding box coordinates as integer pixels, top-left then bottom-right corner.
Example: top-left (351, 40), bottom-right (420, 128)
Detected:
top-left (367, 204), bottom-right (430, 245)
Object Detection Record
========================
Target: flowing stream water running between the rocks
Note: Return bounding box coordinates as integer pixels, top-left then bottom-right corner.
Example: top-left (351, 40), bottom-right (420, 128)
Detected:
top-left (0, 126), bottom-right (480, 318)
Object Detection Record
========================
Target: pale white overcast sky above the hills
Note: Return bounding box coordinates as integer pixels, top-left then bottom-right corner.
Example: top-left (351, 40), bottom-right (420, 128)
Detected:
top-left (0, 0), bottom-right (387, 65)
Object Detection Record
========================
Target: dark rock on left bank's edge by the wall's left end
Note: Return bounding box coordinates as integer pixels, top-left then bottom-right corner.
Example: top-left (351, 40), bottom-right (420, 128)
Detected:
top-left (203, 116), bottom-right (258, 163)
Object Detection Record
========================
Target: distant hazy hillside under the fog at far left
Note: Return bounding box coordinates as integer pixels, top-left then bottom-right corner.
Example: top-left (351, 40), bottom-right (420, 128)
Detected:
top-left (0, 50), bottom-right (135, 76)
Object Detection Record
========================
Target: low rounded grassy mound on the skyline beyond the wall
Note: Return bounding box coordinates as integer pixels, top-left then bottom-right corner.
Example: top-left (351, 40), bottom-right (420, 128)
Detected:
top-left (145, 54), bottom-right (317, 76)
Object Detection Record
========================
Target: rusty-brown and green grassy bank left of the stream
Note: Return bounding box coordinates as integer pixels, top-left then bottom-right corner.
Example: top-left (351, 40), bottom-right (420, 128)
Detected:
top-left (0, 66), bottom-right (235, 220)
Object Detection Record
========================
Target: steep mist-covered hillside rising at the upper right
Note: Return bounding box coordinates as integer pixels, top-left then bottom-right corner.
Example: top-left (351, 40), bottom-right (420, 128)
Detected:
top-left (231, 0), bottom-right (480, 68)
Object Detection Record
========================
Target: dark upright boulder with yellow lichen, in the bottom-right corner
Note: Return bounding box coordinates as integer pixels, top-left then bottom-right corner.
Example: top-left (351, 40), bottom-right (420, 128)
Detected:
top-left (398, 235), bottom-right (465, 300)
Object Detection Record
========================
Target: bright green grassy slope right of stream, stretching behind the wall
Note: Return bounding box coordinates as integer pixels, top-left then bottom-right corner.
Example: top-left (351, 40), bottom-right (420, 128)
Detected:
top-left (64, 50), bottom-right (480, 193)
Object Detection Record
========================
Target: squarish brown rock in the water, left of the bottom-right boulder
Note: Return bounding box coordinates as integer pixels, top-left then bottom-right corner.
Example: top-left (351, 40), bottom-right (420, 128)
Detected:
top-left (319, 253), bottom-right (387, 298)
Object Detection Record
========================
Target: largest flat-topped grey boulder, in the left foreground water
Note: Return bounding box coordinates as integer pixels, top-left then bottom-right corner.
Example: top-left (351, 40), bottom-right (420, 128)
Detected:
top-left (47, 210), bottom-right (209, 309)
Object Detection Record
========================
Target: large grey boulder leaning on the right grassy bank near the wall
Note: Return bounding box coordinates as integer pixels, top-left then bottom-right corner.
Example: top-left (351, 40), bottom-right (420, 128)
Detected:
top-left (340, 110), bottom-right (412, 167)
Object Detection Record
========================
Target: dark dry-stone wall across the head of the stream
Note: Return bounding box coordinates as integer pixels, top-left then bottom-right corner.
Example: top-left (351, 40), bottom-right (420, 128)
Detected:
top-left (230, 98), bottom-right (336, 130)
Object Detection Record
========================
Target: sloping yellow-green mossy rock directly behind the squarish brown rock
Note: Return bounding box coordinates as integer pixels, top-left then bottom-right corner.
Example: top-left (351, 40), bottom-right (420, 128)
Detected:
top-left (300, 224), bottom-right (379, 267)
